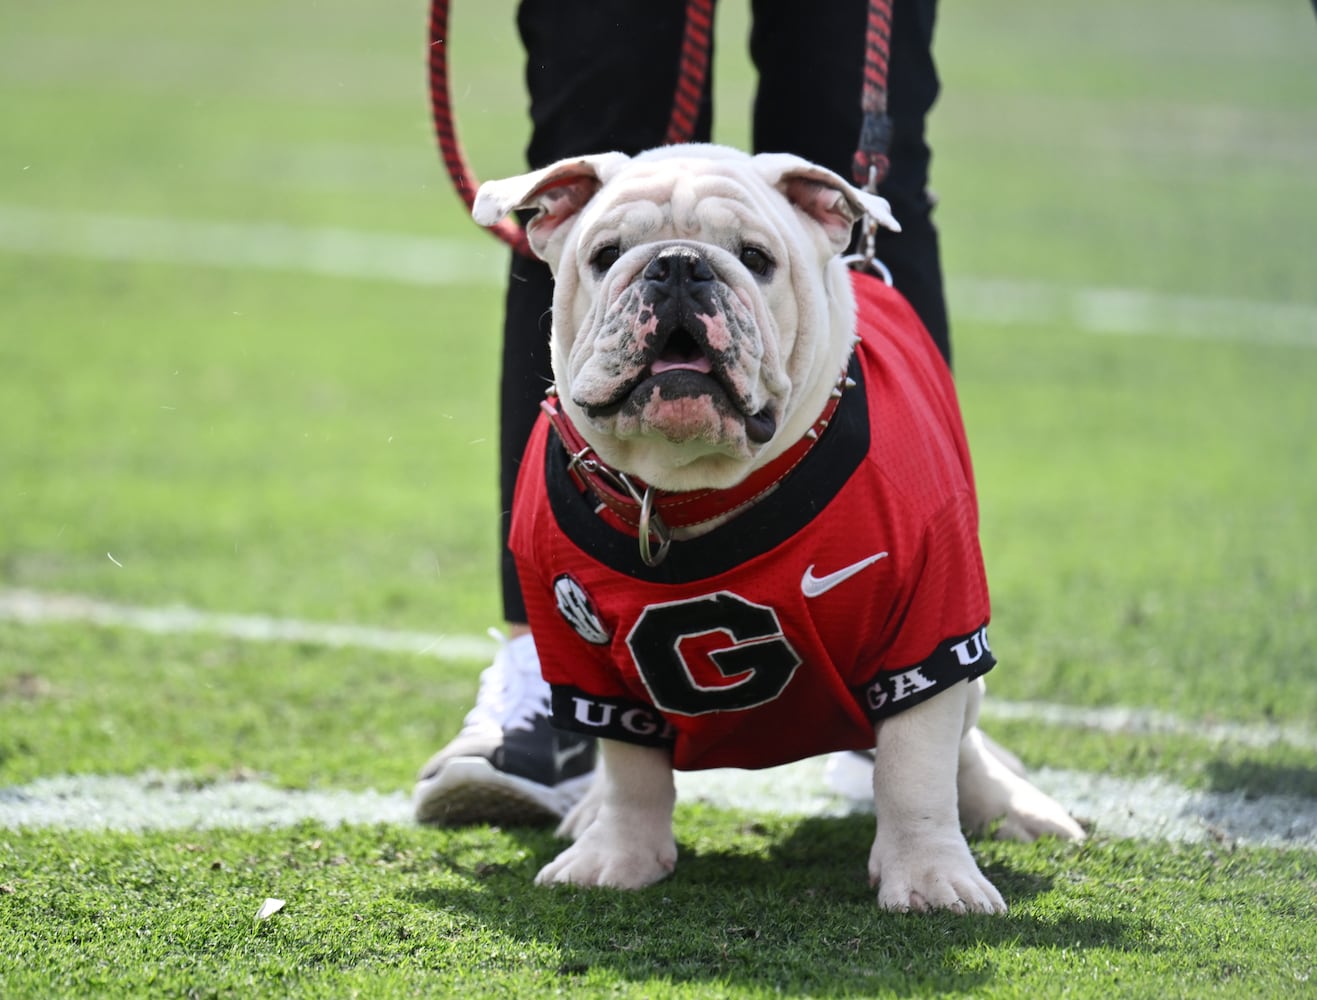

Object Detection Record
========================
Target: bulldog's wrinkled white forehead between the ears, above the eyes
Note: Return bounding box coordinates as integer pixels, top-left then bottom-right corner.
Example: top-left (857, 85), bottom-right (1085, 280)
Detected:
top-left (582, 159), bottom-right (774, 245)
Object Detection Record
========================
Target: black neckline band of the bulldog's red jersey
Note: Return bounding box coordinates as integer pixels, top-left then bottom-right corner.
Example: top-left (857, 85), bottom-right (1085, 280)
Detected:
top-left (544, 354), bottom-right (869, 584)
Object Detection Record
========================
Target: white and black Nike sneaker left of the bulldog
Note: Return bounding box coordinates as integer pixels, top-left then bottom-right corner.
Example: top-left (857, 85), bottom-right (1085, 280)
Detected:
top-left (412, 630), bottom-right (595, 826)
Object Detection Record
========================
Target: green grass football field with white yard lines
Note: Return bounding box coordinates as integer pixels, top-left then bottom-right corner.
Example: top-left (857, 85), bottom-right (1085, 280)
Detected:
top-left (0, 0), bottom-right (1317, 1000)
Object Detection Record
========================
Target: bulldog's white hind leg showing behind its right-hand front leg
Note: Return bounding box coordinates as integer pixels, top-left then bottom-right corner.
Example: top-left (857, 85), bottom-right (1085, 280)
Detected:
top-left (957, 680), bottom-right (1084, 843)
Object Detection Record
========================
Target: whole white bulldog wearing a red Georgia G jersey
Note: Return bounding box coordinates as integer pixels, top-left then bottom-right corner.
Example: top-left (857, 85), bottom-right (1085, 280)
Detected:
top-left (473, 146), bottom-right (1084, 913)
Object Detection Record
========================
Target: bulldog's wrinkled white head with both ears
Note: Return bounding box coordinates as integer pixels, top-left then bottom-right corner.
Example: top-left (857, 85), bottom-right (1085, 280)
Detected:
top-left (474, 146), bottom-right (896, 490)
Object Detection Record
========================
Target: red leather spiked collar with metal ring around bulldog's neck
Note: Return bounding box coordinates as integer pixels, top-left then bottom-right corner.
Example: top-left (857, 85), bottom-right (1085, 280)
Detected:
top-left (540, 372), bottom-right (855, 567)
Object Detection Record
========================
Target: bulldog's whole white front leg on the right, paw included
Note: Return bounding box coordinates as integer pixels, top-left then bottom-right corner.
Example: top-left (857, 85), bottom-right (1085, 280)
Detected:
top-left (869, 684), bottom-right (1006, 913)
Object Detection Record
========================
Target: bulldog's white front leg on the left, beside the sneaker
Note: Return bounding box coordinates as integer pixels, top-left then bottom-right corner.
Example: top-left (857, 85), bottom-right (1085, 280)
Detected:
top-left (535, 739), bottom-right (677, 889)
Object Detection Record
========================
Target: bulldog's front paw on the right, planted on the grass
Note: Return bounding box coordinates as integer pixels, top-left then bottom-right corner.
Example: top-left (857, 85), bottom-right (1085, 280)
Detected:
top-left (869, 834), bottom-right (1006, 913)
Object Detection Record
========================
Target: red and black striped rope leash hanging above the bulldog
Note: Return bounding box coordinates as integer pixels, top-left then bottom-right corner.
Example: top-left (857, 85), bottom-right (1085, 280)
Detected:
top-left (429, 0), bottom-right (892, 256)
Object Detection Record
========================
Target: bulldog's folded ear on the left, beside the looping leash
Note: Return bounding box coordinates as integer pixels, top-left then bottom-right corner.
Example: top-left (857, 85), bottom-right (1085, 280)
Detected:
top-left (471, 153), bottom-right (630, 265)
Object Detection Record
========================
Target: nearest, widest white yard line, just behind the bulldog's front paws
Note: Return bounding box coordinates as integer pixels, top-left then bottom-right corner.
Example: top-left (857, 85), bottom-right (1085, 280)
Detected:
top-left (0, 759), bottom-right (1317, 850)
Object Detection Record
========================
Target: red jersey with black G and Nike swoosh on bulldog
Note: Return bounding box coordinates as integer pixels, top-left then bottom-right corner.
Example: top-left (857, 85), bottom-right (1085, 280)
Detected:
top-left (510, 277), bottom-right (996, 769)
